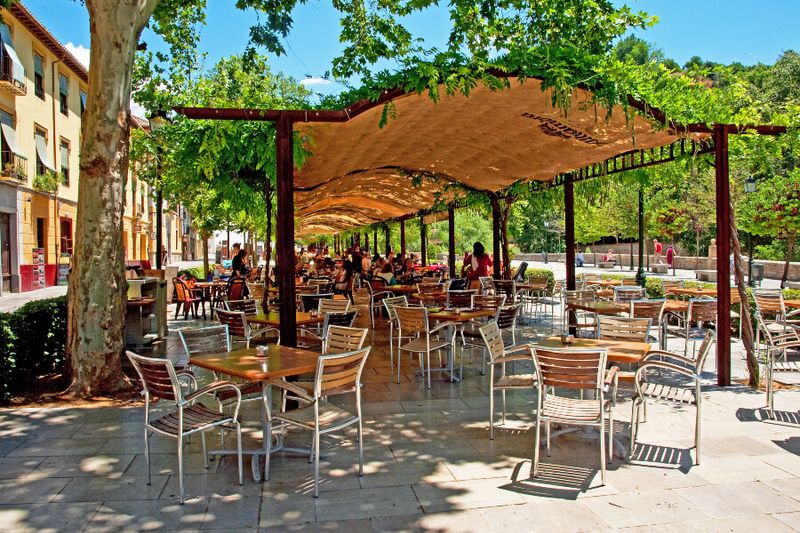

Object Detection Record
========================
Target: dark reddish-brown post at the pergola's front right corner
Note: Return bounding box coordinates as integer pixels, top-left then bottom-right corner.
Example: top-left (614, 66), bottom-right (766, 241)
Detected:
top-left (714, 124), bottom-right (731, 387)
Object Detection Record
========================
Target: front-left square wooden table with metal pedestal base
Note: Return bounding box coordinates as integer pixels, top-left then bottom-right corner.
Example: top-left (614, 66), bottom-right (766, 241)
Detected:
top-left (189, 344), bottom-right (320, 481)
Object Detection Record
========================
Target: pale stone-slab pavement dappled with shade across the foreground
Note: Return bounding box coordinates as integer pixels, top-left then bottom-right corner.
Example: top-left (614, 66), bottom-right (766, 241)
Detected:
top-left (0, 302), bottom-right (800, 533)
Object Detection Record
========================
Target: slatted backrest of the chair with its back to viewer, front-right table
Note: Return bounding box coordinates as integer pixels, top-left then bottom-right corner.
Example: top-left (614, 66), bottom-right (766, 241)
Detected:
top-left (533, 346), bottom-right (608, 392)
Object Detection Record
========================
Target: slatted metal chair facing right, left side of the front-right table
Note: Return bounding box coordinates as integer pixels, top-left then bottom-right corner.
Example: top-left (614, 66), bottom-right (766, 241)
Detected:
top-left (478, 321), bottom-right (536, 440)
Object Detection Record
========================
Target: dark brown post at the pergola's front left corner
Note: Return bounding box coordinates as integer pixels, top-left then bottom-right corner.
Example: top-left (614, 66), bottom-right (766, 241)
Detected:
top-left (275, 112), bottom-right (297, 347)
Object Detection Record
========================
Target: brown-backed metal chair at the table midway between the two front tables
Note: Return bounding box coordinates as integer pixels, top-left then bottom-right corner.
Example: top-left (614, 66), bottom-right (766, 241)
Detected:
top-left (394, 306), bottom-right (454, 389)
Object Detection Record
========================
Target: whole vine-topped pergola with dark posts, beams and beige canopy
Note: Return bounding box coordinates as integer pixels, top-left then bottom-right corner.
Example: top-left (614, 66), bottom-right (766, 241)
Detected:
top-left (176, 77), bottom-right (786, 385)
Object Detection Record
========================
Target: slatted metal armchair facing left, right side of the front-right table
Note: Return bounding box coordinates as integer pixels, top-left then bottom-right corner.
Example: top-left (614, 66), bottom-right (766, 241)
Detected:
top-left (630, 331), bottom-right (714, 465)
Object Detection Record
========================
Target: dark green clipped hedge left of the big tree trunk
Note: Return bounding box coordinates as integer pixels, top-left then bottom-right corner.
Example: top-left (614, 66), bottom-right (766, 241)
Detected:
top-left (0, 296), bottom-right (67, 402)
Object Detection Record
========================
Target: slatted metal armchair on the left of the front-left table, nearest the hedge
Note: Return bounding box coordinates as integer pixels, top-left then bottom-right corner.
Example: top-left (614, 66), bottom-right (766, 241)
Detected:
top-left (126, 352), bottom-right (244, 504)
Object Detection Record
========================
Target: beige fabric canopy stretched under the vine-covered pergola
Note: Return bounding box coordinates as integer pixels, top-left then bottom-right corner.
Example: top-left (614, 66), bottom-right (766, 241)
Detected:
top-left (295, 78), bottom-right (678, 235)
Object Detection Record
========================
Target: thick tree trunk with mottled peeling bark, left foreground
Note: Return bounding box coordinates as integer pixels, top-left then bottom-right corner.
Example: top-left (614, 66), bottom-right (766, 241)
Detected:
top-left (67, 0), bottom-right (158, 397)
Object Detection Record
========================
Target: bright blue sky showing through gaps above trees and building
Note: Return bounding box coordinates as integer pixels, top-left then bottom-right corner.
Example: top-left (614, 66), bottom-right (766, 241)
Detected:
top-left (17, 0), bottom-right (800, 103)
